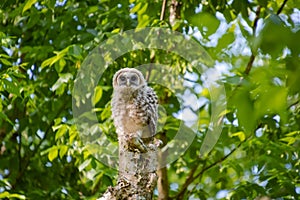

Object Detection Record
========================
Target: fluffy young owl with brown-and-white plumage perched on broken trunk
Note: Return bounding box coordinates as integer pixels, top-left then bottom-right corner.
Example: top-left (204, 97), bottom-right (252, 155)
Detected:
top-left (111, 68), bottom-right (158, 152)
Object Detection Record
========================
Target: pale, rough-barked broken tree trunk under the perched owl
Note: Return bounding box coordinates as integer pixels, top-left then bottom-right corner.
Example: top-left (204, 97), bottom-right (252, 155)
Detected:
top-left (100, 136), bottom-right (157, 200)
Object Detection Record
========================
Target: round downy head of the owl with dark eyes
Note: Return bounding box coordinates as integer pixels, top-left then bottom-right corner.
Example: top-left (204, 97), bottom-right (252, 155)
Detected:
top-left (113, 68), bottom-right (146, 88)
